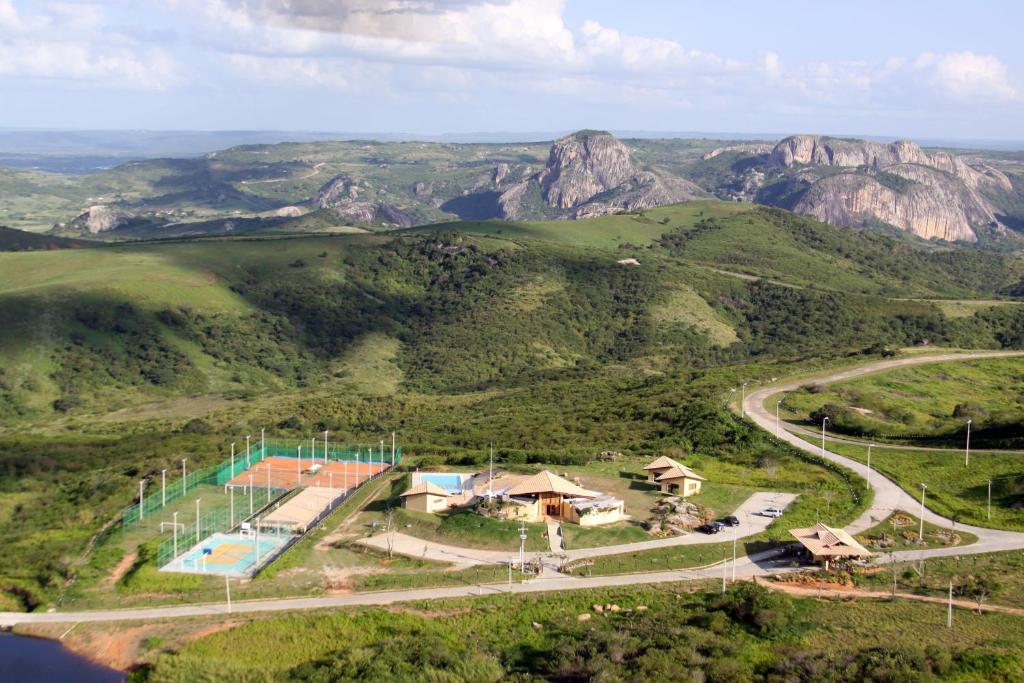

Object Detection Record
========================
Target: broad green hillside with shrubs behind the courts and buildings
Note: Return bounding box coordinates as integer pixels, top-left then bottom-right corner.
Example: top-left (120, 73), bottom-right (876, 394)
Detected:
top-left (0, 203), bottom-right (1024, 606)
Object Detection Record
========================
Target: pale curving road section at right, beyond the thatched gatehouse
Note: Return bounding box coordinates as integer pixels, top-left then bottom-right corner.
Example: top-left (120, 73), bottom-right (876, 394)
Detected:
top-left (742, 351), bottom-right (1024, 548)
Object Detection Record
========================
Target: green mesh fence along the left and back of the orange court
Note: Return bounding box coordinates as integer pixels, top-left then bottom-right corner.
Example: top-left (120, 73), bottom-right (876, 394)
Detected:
top-left (121, 438), bottom-right (401, 529)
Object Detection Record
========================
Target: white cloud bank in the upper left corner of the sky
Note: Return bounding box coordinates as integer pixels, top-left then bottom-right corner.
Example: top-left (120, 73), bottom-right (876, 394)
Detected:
top-left (0, 0), bottom-right (180, 89)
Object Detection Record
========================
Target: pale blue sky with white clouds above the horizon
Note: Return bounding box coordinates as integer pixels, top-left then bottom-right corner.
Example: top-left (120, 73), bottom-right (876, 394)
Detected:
top-left (0, 0), bottom-right (1024, 139)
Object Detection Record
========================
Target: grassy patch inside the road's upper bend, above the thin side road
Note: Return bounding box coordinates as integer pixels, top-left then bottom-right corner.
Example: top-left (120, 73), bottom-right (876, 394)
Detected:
top-left (780, 357), bottom-right (1024, 447)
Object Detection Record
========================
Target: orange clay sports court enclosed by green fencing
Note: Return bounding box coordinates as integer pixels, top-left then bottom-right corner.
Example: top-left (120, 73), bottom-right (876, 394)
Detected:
top-left (226, 456), bottom-right (391, 488)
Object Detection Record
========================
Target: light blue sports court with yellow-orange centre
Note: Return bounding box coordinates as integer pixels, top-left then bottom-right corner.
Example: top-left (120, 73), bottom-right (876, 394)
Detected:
top-left (160, 533), bottom-right (295, 579)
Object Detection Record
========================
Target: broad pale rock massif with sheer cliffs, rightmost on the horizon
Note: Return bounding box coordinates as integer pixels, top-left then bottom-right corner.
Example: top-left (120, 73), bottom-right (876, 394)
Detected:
top-left (770, 135), bottom-right (1012, 242)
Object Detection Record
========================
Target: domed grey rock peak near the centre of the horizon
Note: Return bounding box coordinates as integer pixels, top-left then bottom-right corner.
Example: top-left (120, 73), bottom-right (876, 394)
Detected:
top-left (498, 131), bottom-right (703, 220)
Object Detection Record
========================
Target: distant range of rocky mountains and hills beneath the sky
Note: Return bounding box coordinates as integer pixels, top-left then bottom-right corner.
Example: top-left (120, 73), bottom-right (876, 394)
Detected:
top-left (0, 130), bottom-right (1024, 247)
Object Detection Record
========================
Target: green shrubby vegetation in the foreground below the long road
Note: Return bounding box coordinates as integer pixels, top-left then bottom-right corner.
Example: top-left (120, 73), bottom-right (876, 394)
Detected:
top-left (133, 584), bottom-right (1024, 683)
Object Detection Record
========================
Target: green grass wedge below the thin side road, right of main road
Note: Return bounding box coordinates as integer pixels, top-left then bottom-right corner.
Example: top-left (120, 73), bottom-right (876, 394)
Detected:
top-left (828, 442), bottom-right (1024, 530)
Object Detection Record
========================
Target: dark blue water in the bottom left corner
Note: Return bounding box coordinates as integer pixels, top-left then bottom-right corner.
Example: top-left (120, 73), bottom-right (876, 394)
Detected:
top-left (0, 633), bottom-right (126, 683)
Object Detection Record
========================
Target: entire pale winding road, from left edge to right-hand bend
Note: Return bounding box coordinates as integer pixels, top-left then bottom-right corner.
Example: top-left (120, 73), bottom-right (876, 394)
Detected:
top-left (0, 351), bottom-right (1024, 627)
